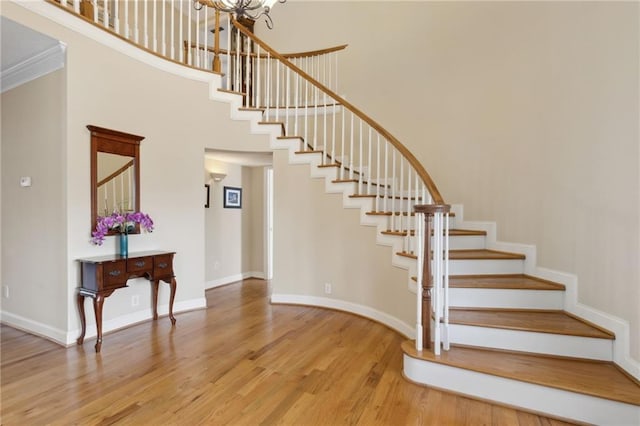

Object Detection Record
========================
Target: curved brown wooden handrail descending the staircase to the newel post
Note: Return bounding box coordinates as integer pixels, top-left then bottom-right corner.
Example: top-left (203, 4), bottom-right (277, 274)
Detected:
top-left (231, 18), bottom-right (445, 204)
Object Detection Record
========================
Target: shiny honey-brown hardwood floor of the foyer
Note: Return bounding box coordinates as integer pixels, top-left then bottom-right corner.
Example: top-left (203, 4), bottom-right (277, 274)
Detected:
top-left (0, 280), bottom-right (568, 426)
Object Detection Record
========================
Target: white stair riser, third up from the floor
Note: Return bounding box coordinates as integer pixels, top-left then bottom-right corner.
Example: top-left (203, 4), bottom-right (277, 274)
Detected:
top-left (449, 288), bottom-right (564, 309)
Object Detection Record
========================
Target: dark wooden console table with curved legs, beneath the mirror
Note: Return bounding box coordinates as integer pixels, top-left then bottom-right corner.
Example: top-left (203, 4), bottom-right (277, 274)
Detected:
top-left (76, 251), bottom-right (176, 352)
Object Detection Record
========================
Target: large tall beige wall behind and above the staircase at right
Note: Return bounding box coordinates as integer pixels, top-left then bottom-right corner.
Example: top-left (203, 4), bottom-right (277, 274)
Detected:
top-left (256, 1), bottom-right (640, 360)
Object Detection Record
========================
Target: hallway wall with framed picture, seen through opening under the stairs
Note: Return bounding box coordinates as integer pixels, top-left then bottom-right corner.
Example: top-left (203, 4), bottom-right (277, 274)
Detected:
top-left (204, 158), bottom-right (265, 287)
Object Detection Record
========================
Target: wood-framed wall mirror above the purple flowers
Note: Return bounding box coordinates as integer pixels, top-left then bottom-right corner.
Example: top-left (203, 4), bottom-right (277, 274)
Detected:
top-left (87, 125), bottom-right (144, 234)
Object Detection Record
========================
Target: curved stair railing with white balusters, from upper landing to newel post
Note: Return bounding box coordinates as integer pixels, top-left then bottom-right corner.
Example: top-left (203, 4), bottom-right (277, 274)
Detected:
top-left (227, 21), bottom-right (450, 354)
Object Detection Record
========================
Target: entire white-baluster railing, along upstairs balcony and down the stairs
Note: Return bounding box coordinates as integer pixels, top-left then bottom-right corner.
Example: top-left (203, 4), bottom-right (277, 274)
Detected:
top-left (46, 0), bottom-right (449, 353)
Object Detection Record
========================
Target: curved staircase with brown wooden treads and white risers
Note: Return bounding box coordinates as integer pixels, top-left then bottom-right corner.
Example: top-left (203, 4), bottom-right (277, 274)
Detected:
top-left (23, 3), bottom-right (640, 425)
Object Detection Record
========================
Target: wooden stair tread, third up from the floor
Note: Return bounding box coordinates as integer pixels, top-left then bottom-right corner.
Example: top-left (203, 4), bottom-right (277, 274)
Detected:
top-left (449, 274), bottom-right (565, 290)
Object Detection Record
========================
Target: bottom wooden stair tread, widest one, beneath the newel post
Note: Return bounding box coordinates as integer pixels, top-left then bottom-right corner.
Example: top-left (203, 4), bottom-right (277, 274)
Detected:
top-left (402, 340), bottom-right (640, 405)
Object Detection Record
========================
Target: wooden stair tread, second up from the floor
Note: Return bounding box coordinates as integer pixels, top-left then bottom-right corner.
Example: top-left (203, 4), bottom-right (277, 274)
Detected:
top-left (449, 308), bottom-right (615, 339)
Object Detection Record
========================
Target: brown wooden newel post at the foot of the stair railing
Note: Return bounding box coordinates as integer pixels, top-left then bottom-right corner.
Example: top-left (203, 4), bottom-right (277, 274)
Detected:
top-left (414, 204), bottom-right (451, 349)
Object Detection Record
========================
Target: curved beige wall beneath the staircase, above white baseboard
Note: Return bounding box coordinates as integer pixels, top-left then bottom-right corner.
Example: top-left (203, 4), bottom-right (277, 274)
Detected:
top-left (272, 151), bottom-right (415, 329)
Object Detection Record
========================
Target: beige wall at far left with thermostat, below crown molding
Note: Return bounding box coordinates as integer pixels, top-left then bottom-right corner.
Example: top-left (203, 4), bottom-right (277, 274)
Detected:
top-left (0, 70), bottom-right (69, 335)
